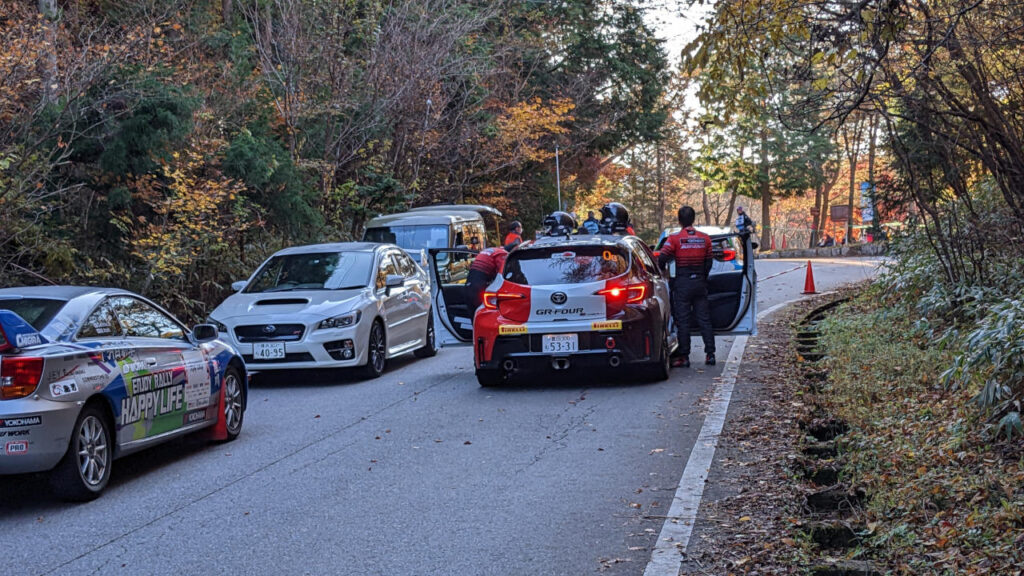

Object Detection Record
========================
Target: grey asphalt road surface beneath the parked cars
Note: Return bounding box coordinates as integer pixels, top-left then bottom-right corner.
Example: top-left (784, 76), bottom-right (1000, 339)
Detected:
top-left (0, 258), bottom-right (879, 575)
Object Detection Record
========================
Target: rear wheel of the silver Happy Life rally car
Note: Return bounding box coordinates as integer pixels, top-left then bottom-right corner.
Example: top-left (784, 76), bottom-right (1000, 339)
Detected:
top-left (50, 404), bottom-right (114, 502)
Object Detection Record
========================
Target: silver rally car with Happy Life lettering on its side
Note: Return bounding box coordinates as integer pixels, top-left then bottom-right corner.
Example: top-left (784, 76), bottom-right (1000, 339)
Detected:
top-left (0, 286), bottom-right (248, 500)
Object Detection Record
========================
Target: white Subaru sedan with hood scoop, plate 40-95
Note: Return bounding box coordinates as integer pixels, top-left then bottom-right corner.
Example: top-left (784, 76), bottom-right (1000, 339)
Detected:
top-left (210, 242), bottom-right (437, 378)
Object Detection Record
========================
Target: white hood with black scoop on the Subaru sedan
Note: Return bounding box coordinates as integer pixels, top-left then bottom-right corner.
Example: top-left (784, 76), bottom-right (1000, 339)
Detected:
top-left (210, 288), bottom-right (370, 322)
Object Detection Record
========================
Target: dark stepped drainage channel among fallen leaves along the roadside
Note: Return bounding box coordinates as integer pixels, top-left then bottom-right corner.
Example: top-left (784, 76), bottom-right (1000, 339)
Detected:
top-left (794, 298), bottom-right (882, 576)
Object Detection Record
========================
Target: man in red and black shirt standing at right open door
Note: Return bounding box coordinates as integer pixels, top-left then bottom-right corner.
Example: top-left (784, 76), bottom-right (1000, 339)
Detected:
top-left (657, 206), bottom-right (715, 368)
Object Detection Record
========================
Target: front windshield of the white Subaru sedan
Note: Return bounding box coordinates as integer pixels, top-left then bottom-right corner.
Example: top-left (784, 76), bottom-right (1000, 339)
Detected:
top-left (245, 252), bottom-right (374, 293)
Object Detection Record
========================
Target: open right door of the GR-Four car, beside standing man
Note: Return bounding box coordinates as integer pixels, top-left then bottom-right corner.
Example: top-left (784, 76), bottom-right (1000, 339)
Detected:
top-left (704, 233), bottom-right (758, 335)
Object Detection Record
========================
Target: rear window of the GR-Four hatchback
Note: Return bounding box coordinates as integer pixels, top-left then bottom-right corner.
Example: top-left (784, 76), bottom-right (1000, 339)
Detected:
top-left (504, 246), bottom-right (630, 286)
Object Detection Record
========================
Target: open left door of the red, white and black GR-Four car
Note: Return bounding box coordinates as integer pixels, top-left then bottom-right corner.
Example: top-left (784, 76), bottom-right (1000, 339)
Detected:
top-left (427, 248), bottom-right (476, 346)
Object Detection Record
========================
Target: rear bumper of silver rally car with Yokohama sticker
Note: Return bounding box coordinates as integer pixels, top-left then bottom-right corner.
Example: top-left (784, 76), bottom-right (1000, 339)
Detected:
top-left (0, 397), bottom-right (79, 475)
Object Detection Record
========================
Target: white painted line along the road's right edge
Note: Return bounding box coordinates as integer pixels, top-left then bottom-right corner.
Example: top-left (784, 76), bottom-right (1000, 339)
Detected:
top-left (643, 300), bottom-right (794, 576)
